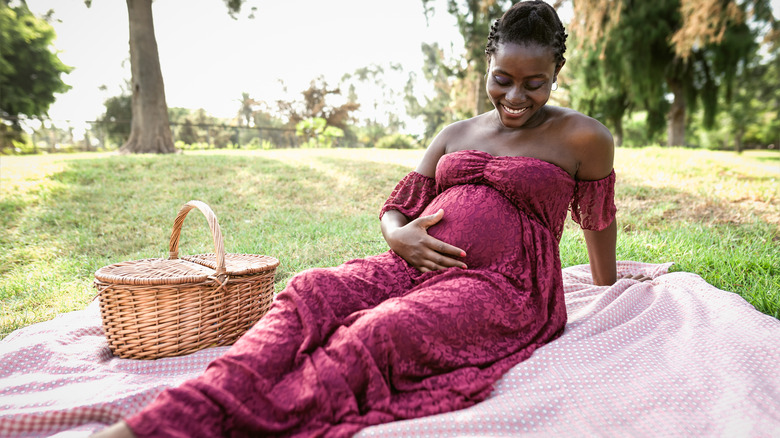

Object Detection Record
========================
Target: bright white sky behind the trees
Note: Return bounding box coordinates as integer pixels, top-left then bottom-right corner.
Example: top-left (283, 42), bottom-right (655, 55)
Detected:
top-left (27, 0), bottom-right (470, 134)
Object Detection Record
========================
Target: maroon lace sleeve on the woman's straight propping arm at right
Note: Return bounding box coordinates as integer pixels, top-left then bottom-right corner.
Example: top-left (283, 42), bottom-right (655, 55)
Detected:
top-left (571, 170), bottom-right (617, 231)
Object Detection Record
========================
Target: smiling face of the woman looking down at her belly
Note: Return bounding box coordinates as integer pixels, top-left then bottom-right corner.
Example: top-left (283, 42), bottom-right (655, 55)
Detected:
top-left (486, 43), bottom-right (562, 128)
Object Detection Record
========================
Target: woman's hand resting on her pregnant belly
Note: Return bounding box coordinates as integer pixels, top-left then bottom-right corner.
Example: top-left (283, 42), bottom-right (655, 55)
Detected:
top-left (385, 210), bottom-right (467, 272)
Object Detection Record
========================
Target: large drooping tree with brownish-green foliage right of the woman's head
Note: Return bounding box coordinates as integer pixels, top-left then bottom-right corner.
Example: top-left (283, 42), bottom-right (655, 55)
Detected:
top-left (571, 0), bottom-right (777, 145)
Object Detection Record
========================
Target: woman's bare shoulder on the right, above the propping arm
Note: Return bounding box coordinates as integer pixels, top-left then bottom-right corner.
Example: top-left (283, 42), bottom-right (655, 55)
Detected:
top-left (558, 108), bottom-right (615, 180)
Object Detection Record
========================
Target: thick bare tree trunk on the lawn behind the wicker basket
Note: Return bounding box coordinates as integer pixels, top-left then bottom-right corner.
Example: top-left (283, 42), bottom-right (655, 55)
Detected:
top-left (120, 0), bottom-right (176, 154)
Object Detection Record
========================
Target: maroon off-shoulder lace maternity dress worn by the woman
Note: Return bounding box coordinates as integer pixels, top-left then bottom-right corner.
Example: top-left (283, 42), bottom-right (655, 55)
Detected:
top-left (127, 150), bottom-right (615, 437)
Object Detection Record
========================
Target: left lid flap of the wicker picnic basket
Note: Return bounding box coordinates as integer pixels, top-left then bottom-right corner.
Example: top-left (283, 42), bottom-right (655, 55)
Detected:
top-left (95, 259), bottom-right (215, 286)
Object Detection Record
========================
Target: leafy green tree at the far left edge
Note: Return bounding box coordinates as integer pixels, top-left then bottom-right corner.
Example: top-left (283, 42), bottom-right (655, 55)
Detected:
top-left (0, 0), bottom-right (71, 152)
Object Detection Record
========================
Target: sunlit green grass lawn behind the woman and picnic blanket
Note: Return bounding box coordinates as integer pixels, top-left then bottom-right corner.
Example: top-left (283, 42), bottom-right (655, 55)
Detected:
top-left (0, 148), bottom-right (780, 338)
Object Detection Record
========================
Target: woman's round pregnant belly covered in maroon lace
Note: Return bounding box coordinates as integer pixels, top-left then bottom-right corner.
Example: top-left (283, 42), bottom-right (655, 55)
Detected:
top-left (422, 185), bottom-right (522, 268)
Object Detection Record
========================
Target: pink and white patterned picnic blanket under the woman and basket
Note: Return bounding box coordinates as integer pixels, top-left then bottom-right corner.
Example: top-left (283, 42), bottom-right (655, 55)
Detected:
top-left (0, 262), bottom-right (780, 438)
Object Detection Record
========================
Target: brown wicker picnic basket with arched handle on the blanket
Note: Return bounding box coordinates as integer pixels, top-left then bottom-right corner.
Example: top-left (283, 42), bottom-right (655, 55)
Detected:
top-left (95, 201), bottom-right (279, 359)
